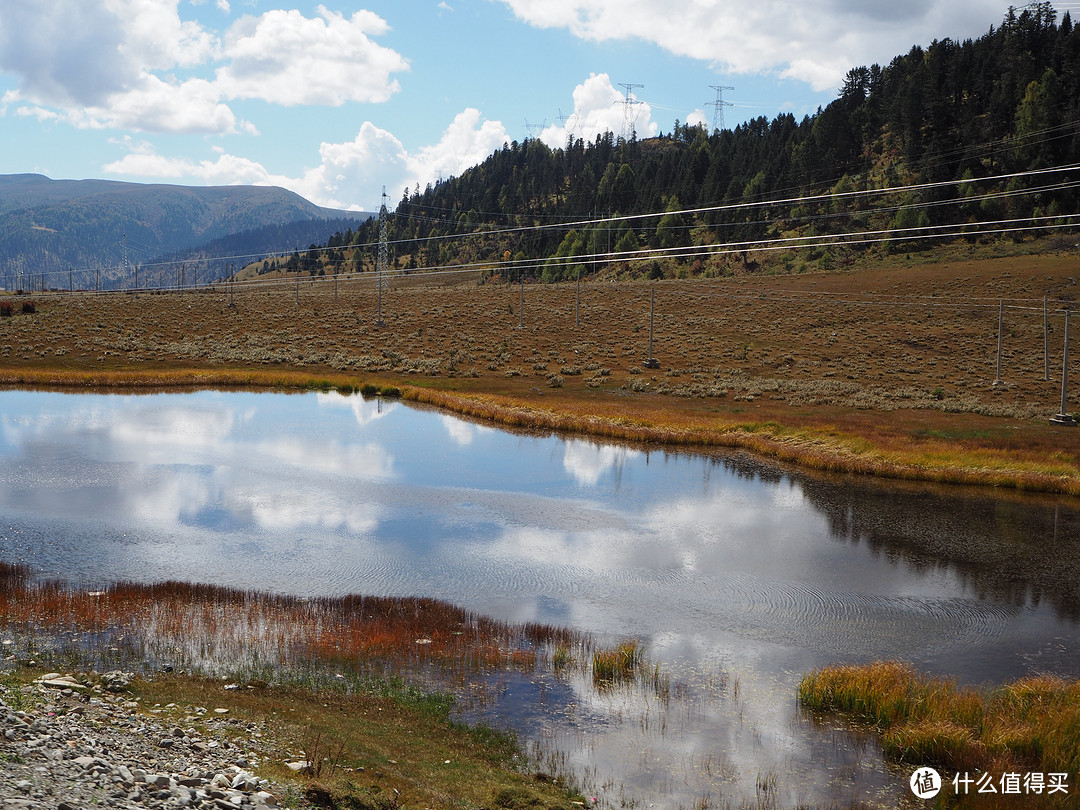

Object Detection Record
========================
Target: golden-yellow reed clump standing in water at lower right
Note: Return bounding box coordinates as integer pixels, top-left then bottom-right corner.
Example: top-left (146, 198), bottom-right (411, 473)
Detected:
top-left (799, 662), bottom-right (1080, 774)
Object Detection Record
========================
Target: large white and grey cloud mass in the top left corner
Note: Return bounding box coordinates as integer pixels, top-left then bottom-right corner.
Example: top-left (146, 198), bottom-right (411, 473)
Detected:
top-left (0, 0), bottom-right (408, 134)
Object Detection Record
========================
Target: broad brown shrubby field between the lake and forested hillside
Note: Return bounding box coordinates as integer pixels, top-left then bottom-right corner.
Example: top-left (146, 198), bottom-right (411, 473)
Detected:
top-left (0, 252), bottom-right (1080, 495)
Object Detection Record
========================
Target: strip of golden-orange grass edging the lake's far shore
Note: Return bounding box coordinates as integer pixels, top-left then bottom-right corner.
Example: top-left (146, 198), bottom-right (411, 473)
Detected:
top-left (0, 367), bottom-right (1080, 497)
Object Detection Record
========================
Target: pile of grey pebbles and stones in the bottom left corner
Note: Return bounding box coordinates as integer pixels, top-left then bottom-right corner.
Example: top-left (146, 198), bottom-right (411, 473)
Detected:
top-left (0, 672), bottom-right (313, 810)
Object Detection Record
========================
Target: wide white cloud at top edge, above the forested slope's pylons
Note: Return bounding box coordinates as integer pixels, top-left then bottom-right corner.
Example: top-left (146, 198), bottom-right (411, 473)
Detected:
top-left (502, 0), bottom-right (1003, 91)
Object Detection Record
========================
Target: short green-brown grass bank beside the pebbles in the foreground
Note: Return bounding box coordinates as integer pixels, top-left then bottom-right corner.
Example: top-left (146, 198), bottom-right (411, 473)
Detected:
top-left (132, 675), bottom-right (582, 810)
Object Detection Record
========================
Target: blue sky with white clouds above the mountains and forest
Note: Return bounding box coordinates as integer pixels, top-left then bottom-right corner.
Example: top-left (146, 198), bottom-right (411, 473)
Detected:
top-left (0, 0), bottom-right (1022, 211)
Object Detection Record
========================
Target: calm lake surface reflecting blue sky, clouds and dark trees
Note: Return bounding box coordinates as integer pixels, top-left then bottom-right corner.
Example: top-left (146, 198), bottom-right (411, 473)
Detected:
top-left (0, 391), bottom-right (1080, 807)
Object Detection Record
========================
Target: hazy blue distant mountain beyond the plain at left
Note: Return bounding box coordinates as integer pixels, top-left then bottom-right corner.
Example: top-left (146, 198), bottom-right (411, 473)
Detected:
top-left (0, 174), bottom-right (370, 288)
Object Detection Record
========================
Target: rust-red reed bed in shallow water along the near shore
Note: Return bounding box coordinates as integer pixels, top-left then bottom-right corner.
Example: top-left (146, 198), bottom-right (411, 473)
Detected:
top-left (0, 563), bottom-right (588, 699)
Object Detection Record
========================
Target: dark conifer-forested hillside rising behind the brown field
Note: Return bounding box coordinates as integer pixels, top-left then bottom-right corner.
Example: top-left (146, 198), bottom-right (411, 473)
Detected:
top-left (332, 3), bottom-right (1080, 280)
